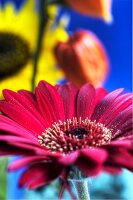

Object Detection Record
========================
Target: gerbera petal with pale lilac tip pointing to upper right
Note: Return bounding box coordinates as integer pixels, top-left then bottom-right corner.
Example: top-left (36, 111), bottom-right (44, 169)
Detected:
top-left (91, 89), bottom-right (123, 121)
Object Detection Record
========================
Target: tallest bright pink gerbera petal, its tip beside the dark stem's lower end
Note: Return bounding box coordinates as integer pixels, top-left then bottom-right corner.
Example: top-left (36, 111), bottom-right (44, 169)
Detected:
top-left (37, 81), bottom-right (65, 120)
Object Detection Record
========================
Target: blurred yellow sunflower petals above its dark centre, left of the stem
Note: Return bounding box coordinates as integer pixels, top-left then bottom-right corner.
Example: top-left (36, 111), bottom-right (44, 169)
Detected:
top-left (0, 0), bottom-right (38, 50)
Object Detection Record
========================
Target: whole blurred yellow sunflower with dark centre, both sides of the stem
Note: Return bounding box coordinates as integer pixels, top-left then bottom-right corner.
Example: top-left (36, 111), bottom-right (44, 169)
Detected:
top-left (0, 0), bottom-right (67, 98)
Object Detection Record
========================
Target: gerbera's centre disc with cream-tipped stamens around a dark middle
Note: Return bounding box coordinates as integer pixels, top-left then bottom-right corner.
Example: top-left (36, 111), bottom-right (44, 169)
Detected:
top-left (38, 117), bottom-right (112, 154)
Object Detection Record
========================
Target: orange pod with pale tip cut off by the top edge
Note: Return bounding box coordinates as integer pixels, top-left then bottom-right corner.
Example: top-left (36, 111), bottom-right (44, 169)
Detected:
top-left (65, 0), bottom-right (112, 22)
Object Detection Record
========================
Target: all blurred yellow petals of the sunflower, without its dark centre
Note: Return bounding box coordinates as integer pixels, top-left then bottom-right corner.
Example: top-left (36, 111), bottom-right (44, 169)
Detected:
top-left (0, 4), bottom-right (68, 98)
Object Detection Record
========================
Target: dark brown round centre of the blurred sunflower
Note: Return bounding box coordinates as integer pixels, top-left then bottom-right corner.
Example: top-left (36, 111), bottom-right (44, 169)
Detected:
top-left (0, 32), bottom-right (30, 79)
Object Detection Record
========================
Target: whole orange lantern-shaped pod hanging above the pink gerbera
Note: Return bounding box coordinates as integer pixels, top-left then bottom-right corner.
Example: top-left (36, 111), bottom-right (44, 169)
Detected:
top-left (54, 31), bottom-right (108, 87)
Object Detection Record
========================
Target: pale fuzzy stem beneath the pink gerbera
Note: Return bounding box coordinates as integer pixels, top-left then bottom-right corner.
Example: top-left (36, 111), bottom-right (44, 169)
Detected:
top-left (70, 179), bottom-right (90, 200)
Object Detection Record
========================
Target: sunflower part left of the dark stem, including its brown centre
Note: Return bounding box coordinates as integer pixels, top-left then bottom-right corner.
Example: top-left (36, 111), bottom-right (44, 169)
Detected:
top-left (0, 0), bottom-right (39, 94)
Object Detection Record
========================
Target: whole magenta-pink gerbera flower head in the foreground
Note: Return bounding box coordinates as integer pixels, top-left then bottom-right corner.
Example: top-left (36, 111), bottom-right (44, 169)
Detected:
top-left (0, 81), bottom-right (133, 194)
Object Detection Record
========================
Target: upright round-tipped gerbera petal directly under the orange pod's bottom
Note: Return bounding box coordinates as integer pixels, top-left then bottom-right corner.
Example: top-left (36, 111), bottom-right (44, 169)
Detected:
top-left (77, 84), bottom-right (95, 119)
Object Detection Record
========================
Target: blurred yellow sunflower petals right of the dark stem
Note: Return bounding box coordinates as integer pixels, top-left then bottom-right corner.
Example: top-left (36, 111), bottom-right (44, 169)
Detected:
top-left (36, 6), bottom-right (69, 85)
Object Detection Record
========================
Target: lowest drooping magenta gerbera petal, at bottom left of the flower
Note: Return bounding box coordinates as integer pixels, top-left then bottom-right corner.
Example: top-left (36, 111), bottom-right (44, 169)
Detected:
top-left (19, 163), bottom-right (62, 189)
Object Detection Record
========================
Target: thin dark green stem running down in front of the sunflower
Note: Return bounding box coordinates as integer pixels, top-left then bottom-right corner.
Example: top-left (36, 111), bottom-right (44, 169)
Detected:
top-left (31, 0), bottom-right (48, 91)
